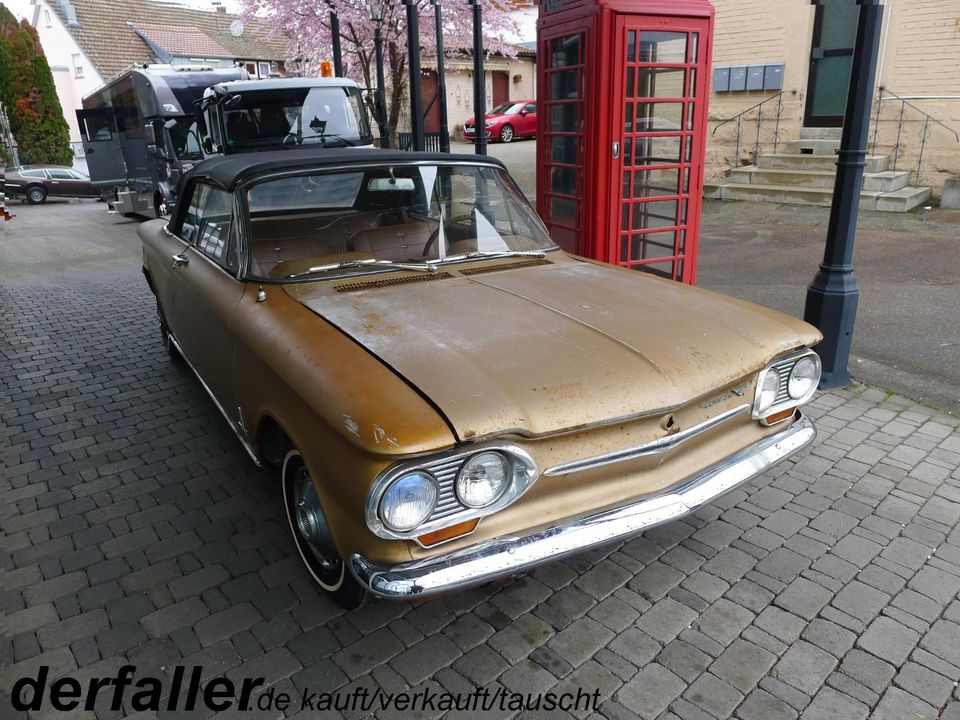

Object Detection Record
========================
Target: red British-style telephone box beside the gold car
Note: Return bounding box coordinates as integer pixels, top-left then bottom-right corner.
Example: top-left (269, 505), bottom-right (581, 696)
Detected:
top-left (537, 0), bottom-right (714, 284)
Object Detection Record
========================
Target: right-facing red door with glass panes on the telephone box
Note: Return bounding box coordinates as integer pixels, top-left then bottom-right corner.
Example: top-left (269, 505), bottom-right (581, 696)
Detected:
top-left (607, 15), bottom-right (709, 283)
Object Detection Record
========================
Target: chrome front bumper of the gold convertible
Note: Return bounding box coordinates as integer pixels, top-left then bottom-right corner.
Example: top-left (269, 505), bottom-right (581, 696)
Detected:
top-left (350, 413), bottom-right (816, 598)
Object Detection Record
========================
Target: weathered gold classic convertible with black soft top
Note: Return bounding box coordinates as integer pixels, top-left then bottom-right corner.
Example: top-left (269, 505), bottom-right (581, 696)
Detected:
top-left (139, 149), bottom-right (820, 607)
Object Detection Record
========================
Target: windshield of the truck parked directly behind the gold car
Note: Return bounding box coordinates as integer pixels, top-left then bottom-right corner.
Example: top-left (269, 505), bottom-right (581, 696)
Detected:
top-left (224, 87), bottom-right (371, 152)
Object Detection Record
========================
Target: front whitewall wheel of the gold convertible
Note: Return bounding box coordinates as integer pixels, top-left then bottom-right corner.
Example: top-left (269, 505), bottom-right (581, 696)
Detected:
top-left (282, 450), bottom-right (366, 610)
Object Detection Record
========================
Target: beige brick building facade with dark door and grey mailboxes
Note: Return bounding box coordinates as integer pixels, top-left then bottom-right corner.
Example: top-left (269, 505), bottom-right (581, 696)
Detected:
top-left (707, 0), bottom-right (960, 202)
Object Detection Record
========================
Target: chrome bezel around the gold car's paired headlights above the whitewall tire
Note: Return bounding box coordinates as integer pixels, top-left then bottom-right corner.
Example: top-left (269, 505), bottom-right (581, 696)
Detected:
top-left (365, 443), bottom-right (540, 540)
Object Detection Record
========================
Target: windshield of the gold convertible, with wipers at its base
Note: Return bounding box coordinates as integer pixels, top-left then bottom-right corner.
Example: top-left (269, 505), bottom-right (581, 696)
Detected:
top-left (247, 163), bottom-right (554, 280)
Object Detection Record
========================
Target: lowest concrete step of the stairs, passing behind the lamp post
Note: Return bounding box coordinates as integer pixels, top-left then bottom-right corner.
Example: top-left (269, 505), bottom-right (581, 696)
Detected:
top-left (704, 183), bottom-right (930, 212)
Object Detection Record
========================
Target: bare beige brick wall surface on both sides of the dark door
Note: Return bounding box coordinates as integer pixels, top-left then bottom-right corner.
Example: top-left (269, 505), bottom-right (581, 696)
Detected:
top-left (707, 0), bottom-right (960, 194)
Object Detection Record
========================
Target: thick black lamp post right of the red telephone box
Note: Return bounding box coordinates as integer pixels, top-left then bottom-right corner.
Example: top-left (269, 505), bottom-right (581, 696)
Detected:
top-left (804, 0), bottom-right (883, 389)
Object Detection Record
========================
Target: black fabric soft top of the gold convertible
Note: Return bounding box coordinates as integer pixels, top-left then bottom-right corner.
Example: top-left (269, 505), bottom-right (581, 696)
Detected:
top-left (180, 147), bottom-right (504, 191)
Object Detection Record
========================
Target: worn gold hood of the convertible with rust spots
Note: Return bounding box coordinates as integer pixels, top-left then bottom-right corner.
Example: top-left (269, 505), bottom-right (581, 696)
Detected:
top-left (286, 253), bottom-right (819, 439)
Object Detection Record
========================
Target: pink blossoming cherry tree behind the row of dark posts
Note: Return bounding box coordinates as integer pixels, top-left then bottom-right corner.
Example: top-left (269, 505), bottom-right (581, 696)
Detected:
top-left (243, 0), bottom-right (517, 139)
